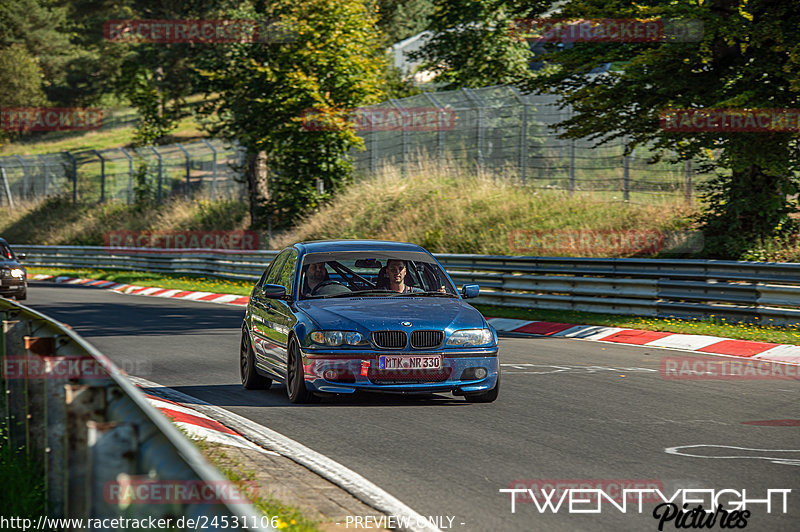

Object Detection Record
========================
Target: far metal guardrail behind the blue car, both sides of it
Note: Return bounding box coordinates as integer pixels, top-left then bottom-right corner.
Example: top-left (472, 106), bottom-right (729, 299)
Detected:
top-left (14, 245), bottom-right (800, 324)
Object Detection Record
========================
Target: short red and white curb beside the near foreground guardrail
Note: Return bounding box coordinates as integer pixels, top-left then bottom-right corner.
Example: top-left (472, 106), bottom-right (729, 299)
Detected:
top-left (144, 393), bottom-right (280, 456)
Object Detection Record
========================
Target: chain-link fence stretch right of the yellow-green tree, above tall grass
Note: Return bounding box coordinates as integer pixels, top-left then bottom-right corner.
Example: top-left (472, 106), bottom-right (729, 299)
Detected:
top-left (354, 86), bottom-right (699, 203)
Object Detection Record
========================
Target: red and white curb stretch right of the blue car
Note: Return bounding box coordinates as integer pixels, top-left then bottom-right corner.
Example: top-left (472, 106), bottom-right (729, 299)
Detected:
top-left (487, 318), bottom-right (800, 364)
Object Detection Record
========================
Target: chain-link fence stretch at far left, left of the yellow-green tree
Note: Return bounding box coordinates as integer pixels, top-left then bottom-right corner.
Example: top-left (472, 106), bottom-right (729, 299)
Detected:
top-left (0, 140), bottom-right (244, 206)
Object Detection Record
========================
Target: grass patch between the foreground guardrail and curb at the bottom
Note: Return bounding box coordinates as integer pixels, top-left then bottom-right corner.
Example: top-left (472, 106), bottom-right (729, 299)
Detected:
top-left (187, 436), bottom-right (320, 532)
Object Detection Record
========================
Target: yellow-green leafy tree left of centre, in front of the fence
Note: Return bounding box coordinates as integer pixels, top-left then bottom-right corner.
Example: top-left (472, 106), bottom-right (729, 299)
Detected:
top-left (203, 0), bottom-right (386, 226)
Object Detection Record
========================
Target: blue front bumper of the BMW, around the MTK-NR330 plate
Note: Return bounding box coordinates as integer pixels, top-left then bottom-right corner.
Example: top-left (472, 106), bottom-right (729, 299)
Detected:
top-left (301, 347), bottom-right (500, 395)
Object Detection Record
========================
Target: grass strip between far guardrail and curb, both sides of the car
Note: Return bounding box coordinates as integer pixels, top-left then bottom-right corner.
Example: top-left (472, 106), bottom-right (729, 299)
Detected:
top-left (28, 268), bottom-right (800, 345)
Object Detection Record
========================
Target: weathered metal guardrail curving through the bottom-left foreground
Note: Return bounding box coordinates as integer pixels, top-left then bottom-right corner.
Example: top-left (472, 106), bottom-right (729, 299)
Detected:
top-left (0, 298), bottom-right (269, 530)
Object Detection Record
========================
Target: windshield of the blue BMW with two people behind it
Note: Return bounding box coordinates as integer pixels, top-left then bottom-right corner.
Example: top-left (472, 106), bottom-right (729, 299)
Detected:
top-left (300, 251), bottom-right (458, 299)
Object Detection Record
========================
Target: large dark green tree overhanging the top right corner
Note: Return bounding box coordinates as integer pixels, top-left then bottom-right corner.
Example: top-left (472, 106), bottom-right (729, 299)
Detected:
top-left (418, 0), bottom-right (800, 258)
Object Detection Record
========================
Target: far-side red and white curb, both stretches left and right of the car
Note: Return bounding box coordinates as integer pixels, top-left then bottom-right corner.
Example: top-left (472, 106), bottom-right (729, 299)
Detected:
top-left (31, 275), bottom-right (800, 364)
